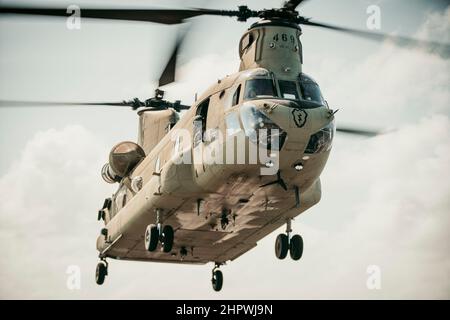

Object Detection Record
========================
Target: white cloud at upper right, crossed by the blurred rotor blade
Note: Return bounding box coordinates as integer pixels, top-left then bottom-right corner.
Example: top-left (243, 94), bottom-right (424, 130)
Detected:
top-left (305, 8), bottom-right (450, 128)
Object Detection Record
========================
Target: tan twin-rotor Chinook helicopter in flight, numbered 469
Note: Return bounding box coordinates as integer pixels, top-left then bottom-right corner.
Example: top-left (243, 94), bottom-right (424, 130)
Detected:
top-left (0, 0), bottom-right (449, 291)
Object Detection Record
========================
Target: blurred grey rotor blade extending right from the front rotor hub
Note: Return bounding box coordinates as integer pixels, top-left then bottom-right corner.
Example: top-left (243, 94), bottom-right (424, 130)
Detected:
top-left (299, 18), bottom-right (450, 57)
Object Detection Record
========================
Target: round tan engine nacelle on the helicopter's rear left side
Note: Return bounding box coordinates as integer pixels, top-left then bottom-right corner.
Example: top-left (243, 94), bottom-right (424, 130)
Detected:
top-left (102, 141), bottom-right (145, 183)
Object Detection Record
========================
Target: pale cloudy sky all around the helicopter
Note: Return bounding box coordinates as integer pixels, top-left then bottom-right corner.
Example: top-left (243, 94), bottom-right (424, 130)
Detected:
top-left (0, 0), bottom-right (450, 300)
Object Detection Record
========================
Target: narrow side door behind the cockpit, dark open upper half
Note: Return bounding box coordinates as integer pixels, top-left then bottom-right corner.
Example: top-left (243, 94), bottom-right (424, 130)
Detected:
top-left (192, 98), bottom-right (209, 176)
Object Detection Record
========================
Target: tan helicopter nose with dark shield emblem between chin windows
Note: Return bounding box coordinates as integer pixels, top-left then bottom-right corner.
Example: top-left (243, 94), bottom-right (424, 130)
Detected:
top-left (237, 99), bottom-right (334, 175)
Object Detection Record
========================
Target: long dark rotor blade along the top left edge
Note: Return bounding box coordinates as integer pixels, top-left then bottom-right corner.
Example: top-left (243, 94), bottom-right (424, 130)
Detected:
top-left (0, 6), bottom-right (229, 24)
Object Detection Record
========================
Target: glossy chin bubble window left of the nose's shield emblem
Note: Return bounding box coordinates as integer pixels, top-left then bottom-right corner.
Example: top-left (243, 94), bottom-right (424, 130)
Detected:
top-left (241, 104), bottom-right (286, 150)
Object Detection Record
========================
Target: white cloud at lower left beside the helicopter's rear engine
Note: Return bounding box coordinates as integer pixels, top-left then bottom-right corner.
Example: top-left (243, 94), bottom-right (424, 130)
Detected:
top-left (0, 126), bottom-right (108, 298)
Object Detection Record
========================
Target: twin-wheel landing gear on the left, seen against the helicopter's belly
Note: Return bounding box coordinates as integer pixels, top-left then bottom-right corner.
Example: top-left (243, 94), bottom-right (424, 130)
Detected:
top-left (144, 209), bottom-right (174, 253)
